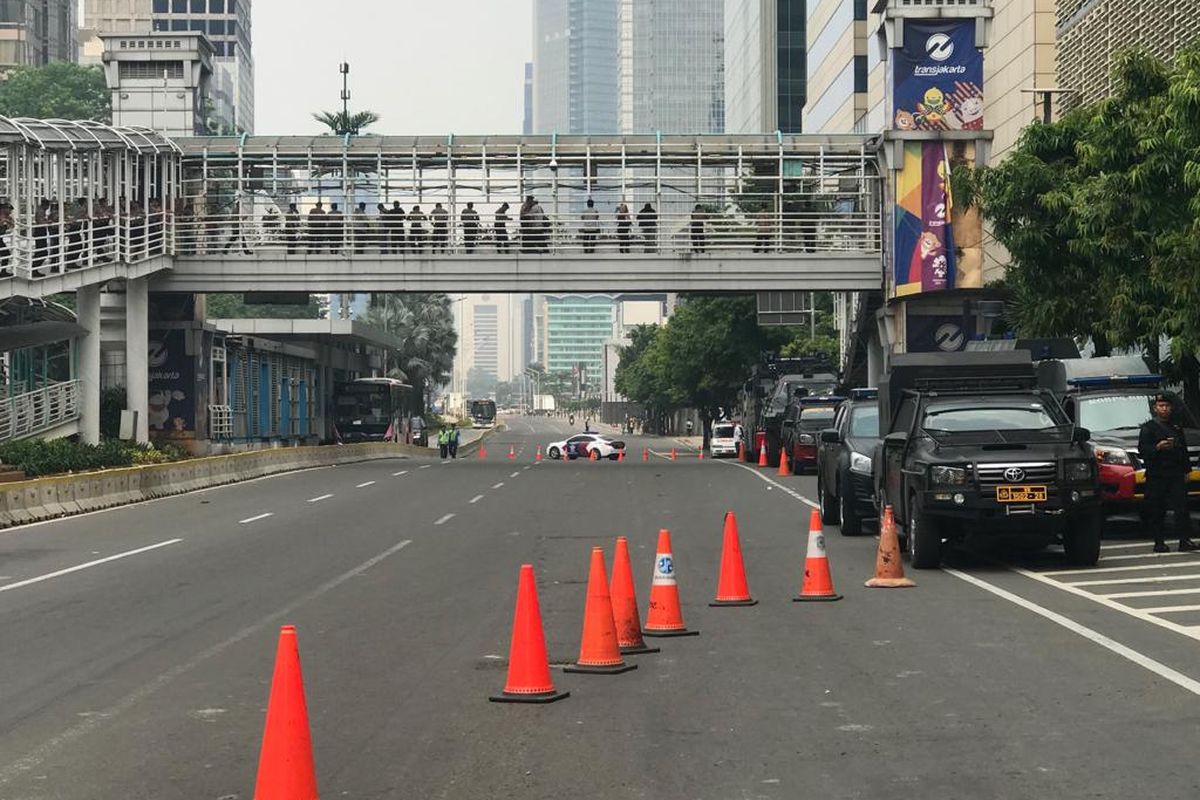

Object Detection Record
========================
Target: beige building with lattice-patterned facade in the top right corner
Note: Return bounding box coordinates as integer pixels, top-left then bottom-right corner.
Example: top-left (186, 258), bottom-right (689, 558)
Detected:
top-left (1055, 0), bottom-right (1200, 109)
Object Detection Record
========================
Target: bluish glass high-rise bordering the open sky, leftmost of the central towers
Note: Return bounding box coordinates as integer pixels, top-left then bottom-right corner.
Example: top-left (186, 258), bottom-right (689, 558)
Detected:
top-left (533, 0), bottom-right (618, 133)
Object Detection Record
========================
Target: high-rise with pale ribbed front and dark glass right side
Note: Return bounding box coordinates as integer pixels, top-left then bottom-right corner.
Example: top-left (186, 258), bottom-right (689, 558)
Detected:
top-left (725, 0), bottom-right (817, 133)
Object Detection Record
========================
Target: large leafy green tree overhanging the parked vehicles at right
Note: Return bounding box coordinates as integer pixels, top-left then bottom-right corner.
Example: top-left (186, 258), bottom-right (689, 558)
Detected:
top-left (979, 49), bottom-right (1200, 403)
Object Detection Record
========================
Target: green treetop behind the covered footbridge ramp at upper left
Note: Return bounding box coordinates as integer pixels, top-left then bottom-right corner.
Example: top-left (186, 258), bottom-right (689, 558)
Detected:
top-left (0, 61), bottom-right (113, 122)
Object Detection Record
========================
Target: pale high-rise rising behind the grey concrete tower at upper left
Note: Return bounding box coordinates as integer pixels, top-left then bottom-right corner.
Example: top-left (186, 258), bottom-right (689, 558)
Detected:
top-left (84, 0), bottom-right (254, 133)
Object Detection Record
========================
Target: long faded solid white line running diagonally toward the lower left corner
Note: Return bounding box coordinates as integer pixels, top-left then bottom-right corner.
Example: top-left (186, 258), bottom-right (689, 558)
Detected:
top-left (0, 539), bottom-right (413, 786)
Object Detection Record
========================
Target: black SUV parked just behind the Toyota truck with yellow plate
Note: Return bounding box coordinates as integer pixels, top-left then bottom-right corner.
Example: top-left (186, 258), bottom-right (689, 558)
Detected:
top-left (817, 389), bottom-right (880, 536)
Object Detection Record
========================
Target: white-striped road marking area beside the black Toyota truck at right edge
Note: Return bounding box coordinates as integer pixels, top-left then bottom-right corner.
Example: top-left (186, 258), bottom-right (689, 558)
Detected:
top-left (1014, 541), bottom-right (1200, 640)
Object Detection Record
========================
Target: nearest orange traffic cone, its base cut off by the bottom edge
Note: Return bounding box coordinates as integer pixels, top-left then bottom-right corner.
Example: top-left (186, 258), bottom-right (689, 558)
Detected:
top-left (254, 625), bottom-right (317, 800)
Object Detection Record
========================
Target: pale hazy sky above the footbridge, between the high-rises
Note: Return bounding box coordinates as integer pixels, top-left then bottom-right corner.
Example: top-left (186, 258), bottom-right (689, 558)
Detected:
top-left (253, 0), bottom-right (533, 134)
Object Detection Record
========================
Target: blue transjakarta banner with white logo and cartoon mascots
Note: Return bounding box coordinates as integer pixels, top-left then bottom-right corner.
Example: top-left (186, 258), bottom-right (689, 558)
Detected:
top-left (892, 19), bottom-right (984, 131)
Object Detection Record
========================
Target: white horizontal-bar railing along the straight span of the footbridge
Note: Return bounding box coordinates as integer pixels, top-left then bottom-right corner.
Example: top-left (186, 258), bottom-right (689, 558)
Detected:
top-left (174, 210), bottom-right (882, 257)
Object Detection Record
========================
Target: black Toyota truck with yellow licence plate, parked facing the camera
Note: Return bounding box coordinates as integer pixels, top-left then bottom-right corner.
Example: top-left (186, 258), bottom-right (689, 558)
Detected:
top-left (872, 350), bottom-right (1102, 569)
